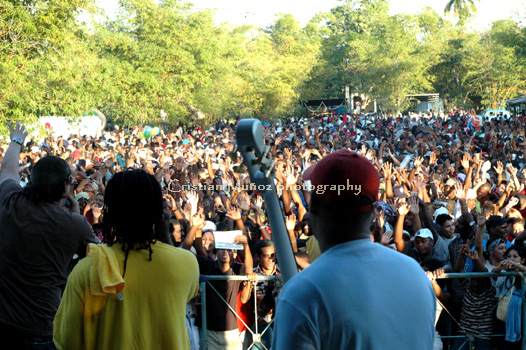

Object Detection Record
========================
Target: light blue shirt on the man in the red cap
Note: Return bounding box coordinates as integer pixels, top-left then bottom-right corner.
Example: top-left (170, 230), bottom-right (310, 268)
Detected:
top-left (272, 239), bottom-right (436, 350)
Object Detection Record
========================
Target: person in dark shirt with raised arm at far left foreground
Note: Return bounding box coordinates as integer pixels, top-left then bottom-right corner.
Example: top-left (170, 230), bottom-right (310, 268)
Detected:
top-left (0, 123), bottom-right (99, 349)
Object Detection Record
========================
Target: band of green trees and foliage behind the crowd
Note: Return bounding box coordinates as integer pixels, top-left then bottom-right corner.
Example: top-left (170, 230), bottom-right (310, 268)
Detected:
top-left (0, 0), bottom-right (526, 128)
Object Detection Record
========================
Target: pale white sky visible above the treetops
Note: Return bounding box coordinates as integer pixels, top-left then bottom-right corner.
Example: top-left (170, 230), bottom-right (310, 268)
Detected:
top-left (98, 0), bottom-right (526, 30)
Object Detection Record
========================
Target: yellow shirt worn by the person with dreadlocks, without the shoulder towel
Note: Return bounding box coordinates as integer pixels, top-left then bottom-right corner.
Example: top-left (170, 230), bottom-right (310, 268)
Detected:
top-left (54, 242), bottom-right (199, 350)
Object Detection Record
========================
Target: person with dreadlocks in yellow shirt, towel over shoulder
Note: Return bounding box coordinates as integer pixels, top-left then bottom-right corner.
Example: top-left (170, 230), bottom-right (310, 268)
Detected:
top-left (54, 170), bottom-right (199, 350)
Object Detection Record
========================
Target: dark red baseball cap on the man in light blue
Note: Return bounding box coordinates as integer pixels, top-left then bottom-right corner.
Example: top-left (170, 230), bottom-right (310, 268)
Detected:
top-left (303, 149), bottom-right (380, 212)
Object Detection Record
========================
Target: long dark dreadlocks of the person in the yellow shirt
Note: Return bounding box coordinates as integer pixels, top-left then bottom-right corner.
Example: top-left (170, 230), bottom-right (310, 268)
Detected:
top-left (102, 170), bottom-right (163, 277)
